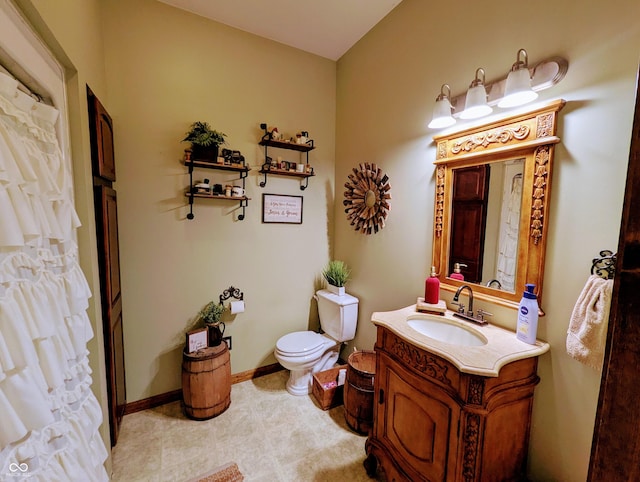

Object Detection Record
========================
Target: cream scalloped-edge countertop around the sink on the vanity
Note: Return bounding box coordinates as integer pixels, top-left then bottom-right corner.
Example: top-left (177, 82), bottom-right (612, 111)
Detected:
top-left (371, 305), bottom-right (549, 377)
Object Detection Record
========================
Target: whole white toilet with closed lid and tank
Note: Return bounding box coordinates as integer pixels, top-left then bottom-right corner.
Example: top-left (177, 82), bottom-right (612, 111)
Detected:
top-left (274, 290), bottom-right (358, 395)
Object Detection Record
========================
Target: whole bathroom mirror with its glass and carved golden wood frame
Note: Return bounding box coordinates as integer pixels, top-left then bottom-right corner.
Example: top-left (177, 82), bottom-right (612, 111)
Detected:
top-left (433, 100), bottom-right (565, 307)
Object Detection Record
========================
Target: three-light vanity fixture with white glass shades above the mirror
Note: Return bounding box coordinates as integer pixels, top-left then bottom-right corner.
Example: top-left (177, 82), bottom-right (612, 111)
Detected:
top-left (429, 49), bottom-right (569, 129)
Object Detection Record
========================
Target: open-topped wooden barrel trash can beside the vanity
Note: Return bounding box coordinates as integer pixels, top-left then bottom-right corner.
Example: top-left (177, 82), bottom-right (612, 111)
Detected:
top-left (344, 350), bottom-right (376, 435)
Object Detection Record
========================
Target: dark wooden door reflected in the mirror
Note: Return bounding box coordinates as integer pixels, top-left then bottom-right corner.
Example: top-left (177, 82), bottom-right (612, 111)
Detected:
top-left (447, 165), bottom-right (489, 283)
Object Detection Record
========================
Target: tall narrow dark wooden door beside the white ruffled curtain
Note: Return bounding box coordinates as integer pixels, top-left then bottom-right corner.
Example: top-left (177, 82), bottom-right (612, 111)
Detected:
top-left (87, 87), bottom-right (127, 446)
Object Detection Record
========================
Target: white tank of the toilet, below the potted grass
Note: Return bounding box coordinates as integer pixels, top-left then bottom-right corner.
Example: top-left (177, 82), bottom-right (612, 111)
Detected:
top-left (316, 290), bottom-right (358, 342)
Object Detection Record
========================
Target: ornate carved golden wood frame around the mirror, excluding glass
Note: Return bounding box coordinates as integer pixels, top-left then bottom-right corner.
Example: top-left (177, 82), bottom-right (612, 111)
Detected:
top-left (433, 100), bottom-right (565, 308)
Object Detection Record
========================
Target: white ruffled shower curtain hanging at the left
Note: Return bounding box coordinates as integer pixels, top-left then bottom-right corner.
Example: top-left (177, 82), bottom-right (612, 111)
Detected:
top-left (0, 72), bottom-right (109, 482)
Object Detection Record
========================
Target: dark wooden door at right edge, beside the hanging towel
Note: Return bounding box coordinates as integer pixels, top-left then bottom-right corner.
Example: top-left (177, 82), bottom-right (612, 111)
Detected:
top-left (588, 66), bottom-right (640, 482)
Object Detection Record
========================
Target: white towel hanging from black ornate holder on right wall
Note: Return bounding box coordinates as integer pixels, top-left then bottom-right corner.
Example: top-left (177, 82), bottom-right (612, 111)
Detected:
top-left (567, 275), bottom-right (613, 370)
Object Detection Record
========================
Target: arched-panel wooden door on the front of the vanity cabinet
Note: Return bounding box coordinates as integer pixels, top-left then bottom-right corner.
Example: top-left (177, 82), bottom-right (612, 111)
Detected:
top-left (375, 353), bottom-right (461, 481)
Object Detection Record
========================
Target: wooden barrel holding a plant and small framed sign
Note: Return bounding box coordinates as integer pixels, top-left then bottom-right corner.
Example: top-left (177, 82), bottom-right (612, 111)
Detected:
top-left (182, 343), bottom-right (231, 420)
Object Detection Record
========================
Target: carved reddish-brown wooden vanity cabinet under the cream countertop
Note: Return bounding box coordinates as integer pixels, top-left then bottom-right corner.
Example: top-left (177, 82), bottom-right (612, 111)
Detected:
top-left (364, 326), bottom-right (539, 482)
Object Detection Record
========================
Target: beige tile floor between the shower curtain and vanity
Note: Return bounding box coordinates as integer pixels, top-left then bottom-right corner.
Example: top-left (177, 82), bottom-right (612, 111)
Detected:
top-left (112, 371), bottom-right (382, 482)
